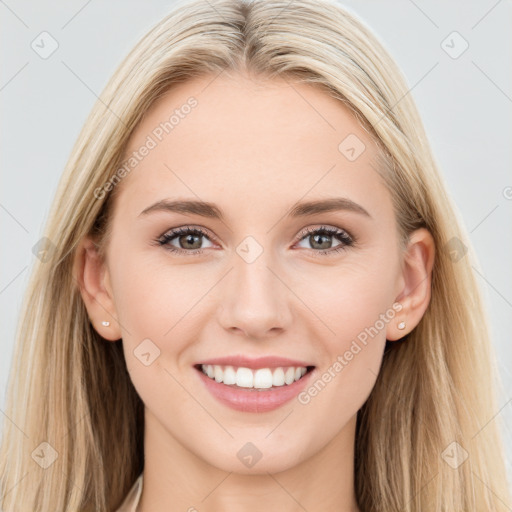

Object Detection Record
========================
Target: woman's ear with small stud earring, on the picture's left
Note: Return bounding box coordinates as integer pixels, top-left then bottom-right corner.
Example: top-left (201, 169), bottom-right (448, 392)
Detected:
top-left (74, 237), bottom-right (121, 341)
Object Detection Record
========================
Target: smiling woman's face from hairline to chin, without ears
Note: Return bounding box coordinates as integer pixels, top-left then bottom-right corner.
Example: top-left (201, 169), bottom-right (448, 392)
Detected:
top-left (86, 71), bottom-right (420, 472)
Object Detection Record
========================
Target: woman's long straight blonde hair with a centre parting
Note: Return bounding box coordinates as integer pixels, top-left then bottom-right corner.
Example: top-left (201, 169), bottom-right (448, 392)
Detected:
top-left (0, 0), bottom-right (512, 512)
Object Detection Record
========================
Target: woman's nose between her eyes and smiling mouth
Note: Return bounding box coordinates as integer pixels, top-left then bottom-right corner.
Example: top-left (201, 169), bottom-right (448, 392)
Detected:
top-left (219, 251), bottom-right (292, 339)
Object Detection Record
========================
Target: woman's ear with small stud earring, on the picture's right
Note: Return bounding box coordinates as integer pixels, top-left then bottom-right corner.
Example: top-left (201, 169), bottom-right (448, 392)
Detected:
top-left (386, 228), bottom-right (435, 341)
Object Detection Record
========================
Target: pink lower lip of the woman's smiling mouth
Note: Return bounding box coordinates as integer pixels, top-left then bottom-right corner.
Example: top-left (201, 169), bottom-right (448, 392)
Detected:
top-left (195, 368), bottom-right (315, 412)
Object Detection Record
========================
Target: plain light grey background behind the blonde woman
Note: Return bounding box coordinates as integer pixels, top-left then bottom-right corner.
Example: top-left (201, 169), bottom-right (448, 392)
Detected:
top-left (0, 0), bottom-right (512, 492)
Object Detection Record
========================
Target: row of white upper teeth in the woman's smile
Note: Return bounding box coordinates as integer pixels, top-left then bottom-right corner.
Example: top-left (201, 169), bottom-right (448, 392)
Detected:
top-left (201, 364), bottom-right (307, 389)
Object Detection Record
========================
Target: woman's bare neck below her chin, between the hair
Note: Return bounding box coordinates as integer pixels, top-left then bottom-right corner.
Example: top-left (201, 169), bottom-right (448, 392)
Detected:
top-left (137, 409), bottom-right (359, 512)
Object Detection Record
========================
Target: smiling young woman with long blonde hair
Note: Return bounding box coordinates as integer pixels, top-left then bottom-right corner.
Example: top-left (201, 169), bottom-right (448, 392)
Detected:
top-left (0, 0), bottom-right (512, 512)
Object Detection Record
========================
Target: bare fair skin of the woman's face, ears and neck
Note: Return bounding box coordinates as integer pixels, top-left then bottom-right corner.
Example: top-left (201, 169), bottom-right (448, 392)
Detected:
top-left (78, 71), bottom-right (434, 512)
